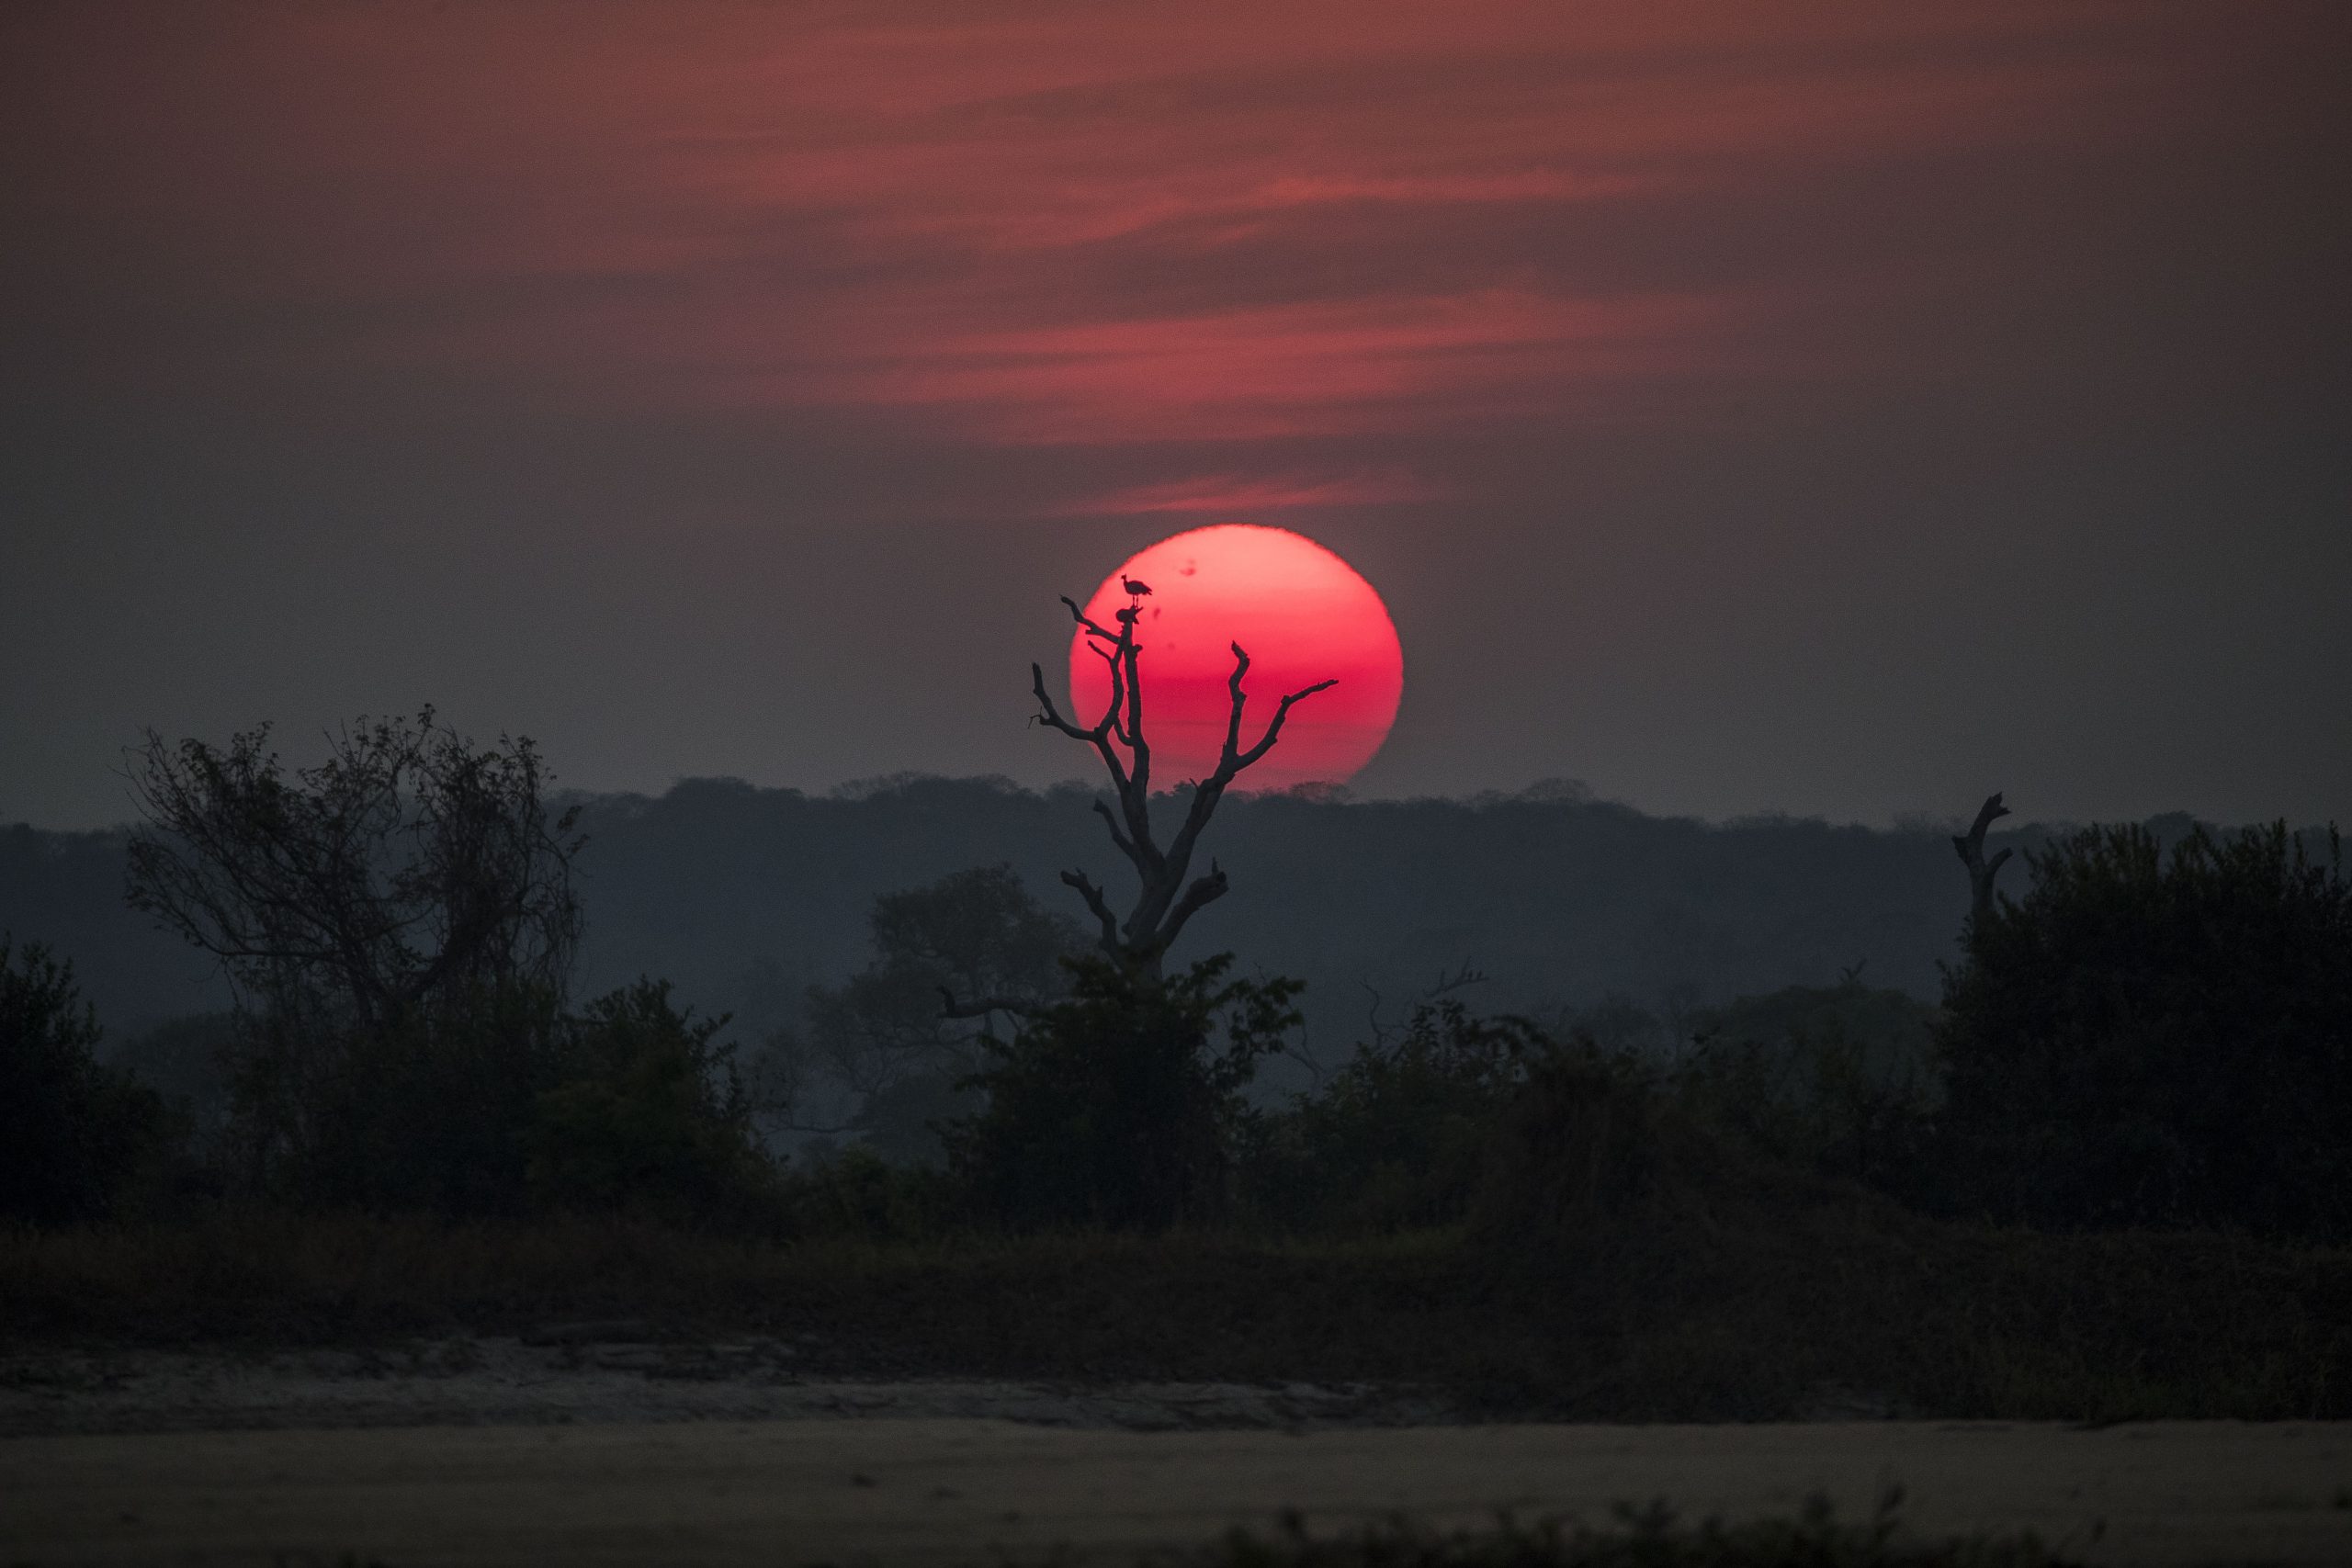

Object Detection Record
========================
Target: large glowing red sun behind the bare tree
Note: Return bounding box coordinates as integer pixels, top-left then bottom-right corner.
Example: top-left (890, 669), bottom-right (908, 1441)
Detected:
top-left (1070, 522), bottom-right (1404, 790)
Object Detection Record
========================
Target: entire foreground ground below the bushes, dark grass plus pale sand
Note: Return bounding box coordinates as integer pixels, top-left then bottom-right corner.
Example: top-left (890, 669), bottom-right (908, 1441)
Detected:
top-left (0, 1203), bottom-right (2352, 1568)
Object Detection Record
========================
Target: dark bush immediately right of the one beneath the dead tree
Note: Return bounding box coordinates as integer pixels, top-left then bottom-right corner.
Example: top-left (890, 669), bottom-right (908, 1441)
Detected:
top-left (1244, 999), bottom-right (1550, 1235)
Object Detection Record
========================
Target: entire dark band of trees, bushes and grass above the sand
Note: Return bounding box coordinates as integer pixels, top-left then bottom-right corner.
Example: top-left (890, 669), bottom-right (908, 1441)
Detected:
top-left (0, 597), bottom-right (2352, 1419)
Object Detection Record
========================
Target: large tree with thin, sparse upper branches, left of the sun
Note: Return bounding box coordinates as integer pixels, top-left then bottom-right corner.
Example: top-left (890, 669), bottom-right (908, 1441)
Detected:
top-left (130, 707), bottom-right (581, 1213)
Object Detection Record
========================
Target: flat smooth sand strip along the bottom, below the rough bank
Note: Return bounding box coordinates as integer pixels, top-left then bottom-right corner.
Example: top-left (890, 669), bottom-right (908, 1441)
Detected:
top-left (0, 1417), bottom-right (2352, 1565)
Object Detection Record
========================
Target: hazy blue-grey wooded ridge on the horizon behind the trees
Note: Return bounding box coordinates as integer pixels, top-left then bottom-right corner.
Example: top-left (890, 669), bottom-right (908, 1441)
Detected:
top-left (0, 776), bottom-right (2295, 1051)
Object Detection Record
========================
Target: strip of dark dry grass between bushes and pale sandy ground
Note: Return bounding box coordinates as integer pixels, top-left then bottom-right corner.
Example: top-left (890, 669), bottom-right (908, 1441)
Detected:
top-left (0, 1199), bottom-right (2352, 1420)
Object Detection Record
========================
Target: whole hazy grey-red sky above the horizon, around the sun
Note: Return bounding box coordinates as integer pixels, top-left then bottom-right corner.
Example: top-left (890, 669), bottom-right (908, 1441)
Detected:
top-left (0, 0), bottom-right (2352, 825)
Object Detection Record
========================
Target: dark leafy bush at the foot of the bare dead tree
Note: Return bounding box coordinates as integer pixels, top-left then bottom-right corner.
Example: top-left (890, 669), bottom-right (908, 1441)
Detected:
top-left (944, 954), bottom-right (1301, 1229)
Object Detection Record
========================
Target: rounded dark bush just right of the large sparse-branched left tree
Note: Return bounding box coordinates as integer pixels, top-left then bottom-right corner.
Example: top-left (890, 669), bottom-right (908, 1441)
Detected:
top-left (525, 980), bottom-right (774, 1223)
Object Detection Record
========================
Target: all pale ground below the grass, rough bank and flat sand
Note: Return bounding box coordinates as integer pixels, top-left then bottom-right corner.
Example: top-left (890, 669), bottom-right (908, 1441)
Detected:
top-left (0, 1325), bottom-right (2352, 1568)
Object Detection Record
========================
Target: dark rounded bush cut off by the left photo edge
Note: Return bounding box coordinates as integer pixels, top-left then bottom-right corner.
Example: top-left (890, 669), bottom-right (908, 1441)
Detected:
top-left (0, 936), bottom-right (164, 1224)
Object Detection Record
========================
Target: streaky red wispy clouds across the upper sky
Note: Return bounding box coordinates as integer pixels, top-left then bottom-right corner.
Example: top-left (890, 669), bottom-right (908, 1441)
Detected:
top-left (0, 0), bottom-right (2229, 513)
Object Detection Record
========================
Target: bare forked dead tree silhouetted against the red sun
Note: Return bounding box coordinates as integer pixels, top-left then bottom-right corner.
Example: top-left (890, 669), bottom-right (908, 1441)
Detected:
top-left (1030, 585), bottom-right (1339, 976)
